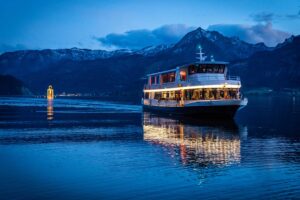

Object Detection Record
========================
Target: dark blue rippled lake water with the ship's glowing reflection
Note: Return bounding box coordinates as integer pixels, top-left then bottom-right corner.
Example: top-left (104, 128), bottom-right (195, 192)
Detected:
top-left (0, 97), bottom-right (300, 200)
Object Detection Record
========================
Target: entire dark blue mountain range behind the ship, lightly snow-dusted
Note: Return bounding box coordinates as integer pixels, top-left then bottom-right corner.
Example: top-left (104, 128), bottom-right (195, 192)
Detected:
top-left (0, 28), bottom-right (300, 99)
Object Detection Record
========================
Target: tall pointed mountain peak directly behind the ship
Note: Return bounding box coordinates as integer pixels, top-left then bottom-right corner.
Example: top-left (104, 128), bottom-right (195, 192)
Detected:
top-left (139, 28), bottom-right (272, 73)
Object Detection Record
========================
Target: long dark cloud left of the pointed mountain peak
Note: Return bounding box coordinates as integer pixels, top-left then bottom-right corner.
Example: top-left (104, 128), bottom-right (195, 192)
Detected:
top-left (96, 24), bottom-right (196, 49)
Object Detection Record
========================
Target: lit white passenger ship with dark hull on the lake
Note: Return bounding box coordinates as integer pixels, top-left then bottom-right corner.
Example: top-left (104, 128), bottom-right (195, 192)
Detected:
top-left (142, 47), bottom-right (248, 117)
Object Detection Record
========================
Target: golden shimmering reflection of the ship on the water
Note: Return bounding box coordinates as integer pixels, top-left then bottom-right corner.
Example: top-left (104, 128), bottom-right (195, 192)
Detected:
top-left (143, 113), bottom-right (247, 167)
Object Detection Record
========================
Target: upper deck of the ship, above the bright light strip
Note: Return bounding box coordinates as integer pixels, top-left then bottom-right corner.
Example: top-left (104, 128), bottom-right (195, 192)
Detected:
top-left (145, 61), bottom-right (241, 90)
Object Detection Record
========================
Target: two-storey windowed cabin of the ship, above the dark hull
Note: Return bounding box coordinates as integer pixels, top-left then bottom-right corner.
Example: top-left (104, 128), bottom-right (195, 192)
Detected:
top-left (143, 61), bottom-right (241, 105)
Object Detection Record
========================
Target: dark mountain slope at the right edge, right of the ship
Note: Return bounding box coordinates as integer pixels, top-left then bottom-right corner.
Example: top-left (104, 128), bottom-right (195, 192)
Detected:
top-left (231, 36), bottom-right (300, 89)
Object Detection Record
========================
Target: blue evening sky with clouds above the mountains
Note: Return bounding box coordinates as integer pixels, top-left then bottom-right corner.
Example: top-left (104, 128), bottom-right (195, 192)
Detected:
top-left (0, 0), bottom-right (300, 52)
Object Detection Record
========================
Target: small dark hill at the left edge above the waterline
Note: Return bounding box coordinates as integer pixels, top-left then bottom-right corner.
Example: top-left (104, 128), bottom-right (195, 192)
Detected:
top-left (0, 75), bottom-right (31, 95)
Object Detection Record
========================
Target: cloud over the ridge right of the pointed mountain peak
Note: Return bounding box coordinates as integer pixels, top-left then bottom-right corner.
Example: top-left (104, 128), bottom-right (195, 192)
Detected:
top-left (208, 22), bottom-right (291, 46)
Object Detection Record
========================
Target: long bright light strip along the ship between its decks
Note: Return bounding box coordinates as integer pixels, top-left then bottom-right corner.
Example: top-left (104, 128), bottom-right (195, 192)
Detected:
top-left (144, 83), bottom-right (241, 92)
